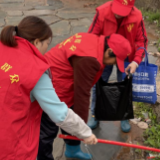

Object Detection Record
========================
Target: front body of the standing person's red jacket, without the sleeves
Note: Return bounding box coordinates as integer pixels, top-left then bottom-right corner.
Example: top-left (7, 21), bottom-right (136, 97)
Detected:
top-left (96, 1), bottom-right (143, 62)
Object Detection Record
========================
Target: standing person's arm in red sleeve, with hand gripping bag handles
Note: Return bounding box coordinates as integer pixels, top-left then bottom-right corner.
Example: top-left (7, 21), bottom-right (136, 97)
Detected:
top-left (125, 20), bottom-right (148, 73)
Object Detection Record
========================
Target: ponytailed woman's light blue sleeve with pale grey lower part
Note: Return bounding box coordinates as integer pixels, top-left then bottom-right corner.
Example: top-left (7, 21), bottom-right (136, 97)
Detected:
top-left (31, 73), bottom-right (92, 139)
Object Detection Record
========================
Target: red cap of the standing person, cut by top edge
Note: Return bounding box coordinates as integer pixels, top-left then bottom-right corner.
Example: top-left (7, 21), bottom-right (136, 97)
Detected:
top-left (112, 0), bottom-right (135, 17)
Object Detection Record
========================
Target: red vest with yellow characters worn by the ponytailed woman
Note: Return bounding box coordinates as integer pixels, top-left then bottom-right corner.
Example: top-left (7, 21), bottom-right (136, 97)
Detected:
top-left (0, 37), bottom-right (49, 160)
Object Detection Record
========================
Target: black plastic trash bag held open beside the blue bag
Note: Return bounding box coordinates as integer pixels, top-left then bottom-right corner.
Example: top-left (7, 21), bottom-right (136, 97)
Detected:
top-left (95, 76), bottom-right (134, 121)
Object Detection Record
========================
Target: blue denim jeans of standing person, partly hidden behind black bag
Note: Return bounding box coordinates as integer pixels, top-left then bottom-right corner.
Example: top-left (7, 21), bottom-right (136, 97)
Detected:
top-left (91, 65), bottom-right (122, 115)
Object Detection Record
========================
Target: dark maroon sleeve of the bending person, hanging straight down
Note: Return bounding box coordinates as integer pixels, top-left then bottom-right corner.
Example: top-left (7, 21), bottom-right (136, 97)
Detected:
top-left (70, 56), bottom-right (100, 122)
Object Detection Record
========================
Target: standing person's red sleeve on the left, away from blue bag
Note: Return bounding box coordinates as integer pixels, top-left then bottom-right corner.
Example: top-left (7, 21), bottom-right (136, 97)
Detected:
top-left (88, 11), bottom-right (103, 35)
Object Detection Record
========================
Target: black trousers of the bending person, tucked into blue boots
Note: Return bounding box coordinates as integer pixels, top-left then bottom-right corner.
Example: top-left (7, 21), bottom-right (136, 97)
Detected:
top-left (37, 109), bottom-right (81, 160)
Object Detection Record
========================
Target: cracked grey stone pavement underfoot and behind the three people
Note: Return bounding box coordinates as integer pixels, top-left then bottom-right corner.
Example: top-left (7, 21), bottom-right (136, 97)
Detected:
top-left (0, 0), bottom-right (159, 160)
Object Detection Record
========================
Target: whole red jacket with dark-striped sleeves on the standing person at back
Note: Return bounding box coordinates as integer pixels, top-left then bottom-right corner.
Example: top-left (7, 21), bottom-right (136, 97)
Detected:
top-left (89, 1), bottom-right (148, 64)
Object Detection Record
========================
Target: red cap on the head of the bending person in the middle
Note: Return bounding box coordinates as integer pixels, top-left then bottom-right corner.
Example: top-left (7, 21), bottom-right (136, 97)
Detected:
top-left (107, 34), bottom-right (132, 72)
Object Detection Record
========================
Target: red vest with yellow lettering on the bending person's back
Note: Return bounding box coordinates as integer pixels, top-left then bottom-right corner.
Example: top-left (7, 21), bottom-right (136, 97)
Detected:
top-left (45, 33), bottom-right (104, 107)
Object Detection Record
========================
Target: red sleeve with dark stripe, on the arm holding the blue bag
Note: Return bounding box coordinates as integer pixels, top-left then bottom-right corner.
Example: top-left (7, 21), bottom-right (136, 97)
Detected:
top-left (133, 20), bottom-right (148, 64)
